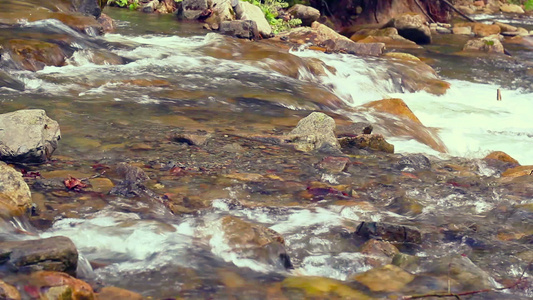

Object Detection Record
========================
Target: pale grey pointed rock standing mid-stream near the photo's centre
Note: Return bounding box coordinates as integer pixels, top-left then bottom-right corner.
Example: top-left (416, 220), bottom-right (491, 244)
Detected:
top-left (287, 112), bottom-right (340, 152)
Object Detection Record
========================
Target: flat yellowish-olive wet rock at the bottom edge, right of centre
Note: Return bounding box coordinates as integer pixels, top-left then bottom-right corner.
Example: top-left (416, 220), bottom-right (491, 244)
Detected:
top-left (281, 276), bottom-right (373, 300)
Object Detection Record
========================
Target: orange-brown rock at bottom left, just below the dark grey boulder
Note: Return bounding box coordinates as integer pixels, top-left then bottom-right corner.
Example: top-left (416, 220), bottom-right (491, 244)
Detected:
top-left (27, 271), bottom-right (96, 300)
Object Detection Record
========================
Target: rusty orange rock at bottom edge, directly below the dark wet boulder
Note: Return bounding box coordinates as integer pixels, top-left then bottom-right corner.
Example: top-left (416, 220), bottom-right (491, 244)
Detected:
top-left (31, 271), bottom-right (95, 300)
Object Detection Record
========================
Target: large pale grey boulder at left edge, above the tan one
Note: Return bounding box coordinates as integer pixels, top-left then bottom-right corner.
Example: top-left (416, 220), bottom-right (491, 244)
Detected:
top-left (0, 109), bottom-right (61, 163)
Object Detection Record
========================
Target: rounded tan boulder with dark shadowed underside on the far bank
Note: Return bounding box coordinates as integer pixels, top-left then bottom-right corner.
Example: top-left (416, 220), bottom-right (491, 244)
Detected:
top-left (391, 13), bottom-right (431, 44)
